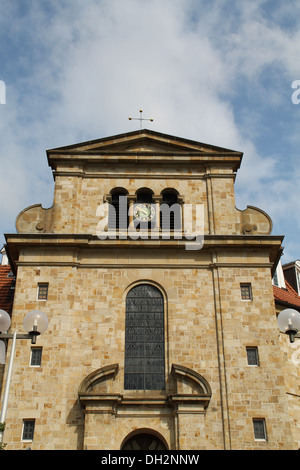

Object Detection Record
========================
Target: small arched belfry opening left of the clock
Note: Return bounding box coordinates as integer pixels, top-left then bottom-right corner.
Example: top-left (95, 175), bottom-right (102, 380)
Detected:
top-left (108, 188), bottom-right (128, 230)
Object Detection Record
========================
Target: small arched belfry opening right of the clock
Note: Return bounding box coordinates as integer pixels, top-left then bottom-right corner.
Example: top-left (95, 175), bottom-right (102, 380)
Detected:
top-left (160, 188), bottom-right (182, 230)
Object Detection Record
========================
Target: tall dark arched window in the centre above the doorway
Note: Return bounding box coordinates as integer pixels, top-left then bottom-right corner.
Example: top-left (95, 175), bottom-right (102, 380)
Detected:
top-left (124, 284), bottom-right (165, 390)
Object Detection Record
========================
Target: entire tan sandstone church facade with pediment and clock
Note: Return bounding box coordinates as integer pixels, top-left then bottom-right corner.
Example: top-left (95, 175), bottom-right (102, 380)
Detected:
top-left (4, 130), bottom-right (299, 450)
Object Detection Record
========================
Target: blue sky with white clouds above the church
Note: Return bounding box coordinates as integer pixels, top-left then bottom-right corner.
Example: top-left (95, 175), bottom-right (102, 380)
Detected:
top-left (0, 0), bottom-right (300, 263)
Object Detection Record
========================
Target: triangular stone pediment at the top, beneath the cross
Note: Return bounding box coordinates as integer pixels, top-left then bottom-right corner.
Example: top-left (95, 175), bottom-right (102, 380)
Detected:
top-left (47, 129), bottom-right (244, 155)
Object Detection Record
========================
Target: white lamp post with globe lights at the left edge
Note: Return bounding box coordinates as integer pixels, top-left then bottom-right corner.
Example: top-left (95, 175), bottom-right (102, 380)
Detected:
top-left (0, 310), bottom-right (48, 443)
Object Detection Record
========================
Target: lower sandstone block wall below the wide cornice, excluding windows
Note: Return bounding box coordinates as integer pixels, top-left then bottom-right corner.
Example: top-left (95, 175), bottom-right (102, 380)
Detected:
top-left (0, 246), bottom-right (293, 449)
